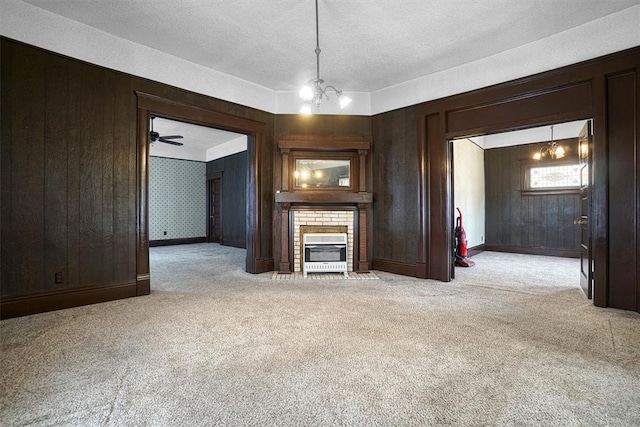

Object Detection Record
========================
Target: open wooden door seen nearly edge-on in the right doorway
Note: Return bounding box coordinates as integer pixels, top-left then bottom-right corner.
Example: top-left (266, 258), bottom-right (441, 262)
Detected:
top-left (574, 120), bottom-right (593, 299)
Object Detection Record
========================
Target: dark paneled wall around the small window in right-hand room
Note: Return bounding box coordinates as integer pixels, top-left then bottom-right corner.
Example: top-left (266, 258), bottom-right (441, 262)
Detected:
top-left (484, 144), bottom-right (580, 257)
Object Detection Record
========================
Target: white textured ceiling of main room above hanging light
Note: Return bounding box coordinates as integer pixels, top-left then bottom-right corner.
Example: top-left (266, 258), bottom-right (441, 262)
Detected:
top-left (20, 0), bottom-right (640, 92)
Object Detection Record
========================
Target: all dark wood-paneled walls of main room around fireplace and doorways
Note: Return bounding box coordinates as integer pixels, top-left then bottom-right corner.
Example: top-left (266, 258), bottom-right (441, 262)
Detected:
top-left (0, 38), bottom-right (640, 317)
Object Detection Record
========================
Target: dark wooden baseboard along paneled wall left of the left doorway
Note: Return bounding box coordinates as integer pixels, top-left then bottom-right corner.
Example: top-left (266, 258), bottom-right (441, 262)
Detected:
top-left (0, 282), bottom-right (137, 319)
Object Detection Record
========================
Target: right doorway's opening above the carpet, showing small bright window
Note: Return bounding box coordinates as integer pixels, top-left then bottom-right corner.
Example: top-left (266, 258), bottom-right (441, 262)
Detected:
top-left (450, 120), bottom-right (592, 298)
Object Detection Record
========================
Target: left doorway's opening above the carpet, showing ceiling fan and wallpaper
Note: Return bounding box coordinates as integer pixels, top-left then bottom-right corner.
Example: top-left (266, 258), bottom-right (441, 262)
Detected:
top-left (149, 116), bottom-right (247, 290)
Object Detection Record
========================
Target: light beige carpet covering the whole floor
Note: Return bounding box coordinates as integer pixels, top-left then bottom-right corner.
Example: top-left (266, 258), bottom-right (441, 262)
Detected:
top-left (0, 244), bottom-right (640, 426)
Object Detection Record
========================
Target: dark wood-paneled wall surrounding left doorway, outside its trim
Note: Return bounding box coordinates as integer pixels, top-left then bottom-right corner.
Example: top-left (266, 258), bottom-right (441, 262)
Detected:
top-left (0, 38), bottom-right (274, 318)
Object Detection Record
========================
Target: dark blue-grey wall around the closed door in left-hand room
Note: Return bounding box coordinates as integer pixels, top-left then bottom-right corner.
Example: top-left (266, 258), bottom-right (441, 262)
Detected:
top-left (207, 151), bottom-right (247, 248)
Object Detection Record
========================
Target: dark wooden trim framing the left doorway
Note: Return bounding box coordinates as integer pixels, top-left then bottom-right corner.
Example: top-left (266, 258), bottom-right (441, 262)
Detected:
top-left (136, 91), bottom-right (268, 274)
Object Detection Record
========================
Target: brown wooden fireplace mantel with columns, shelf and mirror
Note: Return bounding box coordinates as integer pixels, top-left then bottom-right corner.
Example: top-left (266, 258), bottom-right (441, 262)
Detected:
top-left (274, 135), bottom-right (373, 273)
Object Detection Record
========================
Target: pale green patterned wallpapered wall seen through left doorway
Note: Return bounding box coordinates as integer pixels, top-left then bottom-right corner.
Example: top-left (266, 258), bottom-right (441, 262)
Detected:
top-left (149, 157), bottom-right (207, 240)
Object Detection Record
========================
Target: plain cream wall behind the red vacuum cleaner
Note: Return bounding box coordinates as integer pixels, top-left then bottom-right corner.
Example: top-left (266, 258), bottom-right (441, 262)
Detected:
top-left (453, 138), bottom-right (485, 248)
